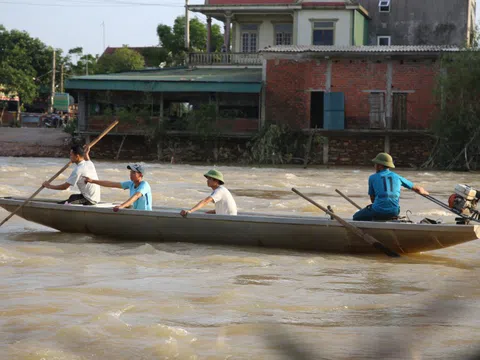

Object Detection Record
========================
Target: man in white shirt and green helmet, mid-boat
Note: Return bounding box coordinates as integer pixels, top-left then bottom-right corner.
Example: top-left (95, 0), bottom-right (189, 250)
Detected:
top-left (180, 170), bottom-right (237, 217)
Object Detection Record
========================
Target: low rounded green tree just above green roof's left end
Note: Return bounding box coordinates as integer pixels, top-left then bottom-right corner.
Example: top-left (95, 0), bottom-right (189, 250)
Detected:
top-left (97, 45), bottom-right (145, 74)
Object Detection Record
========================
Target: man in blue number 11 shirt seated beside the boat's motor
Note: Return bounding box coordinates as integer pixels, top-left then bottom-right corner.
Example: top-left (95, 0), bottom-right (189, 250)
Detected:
top-left (353, 153), bottom-right (428, 221)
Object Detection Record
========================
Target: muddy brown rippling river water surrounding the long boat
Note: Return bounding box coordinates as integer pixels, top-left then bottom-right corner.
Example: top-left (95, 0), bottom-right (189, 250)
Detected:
top-left (0, 158), bottom-right (480, 360)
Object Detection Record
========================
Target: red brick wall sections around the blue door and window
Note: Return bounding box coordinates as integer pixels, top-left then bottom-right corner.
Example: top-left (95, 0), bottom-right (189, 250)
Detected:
top-left (266, 59), bottom-right (437, 129)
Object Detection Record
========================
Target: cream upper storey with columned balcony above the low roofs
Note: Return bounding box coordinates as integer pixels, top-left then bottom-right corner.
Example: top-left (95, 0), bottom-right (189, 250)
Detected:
top-left (188, 0), bottom-right (369, 65)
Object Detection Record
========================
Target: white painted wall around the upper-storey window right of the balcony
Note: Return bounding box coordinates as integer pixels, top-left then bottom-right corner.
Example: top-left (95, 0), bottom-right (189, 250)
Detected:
top-left (294, 10), bottom-right (353, 46)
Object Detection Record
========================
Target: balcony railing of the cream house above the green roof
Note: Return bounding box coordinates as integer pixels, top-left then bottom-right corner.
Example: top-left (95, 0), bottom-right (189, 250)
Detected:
top-left (188, 53), bottom-right (262, 65)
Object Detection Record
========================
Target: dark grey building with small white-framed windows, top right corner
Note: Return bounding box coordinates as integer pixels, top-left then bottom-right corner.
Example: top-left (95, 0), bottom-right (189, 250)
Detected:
top-left (359, 0), bottom-right (476, 46)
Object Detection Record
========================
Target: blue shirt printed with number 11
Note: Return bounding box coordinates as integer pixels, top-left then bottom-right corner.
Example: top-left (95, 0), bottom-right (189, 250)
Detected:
top-left (368, 169), bottom-right (413, 215)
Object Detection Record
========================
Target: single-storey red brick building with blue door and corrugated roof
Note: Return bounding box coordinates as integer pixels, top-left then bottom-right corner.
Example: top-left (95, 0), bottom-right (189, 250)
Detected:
top-left (262, 46), bottom-right (458, 131)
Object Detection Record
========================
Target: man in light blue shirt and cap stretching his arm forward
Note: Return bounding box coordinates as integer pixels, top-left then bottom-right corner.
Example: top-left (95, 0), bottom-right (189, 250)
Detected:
top-left (81, 164), bottom-right (152, 212)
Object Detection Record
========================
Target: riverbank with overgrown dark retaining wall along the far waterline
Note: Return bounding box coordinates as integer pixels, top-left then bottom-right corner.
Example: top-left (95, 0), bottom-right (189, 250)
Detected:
top-left (0, 128), bottom-right (433, 168)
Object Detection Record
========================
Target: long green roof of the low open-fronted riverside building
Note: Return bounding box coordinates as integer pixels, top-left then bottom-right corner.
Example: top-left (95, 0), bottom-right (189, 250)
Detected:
top-left (65, 68), bottom-right (262, 93)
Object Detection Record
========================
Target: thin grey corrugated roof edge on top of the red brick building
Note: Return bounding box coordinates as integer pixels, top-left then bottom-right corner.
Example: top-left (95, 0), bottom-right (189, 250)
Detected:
top-left (260, 45), bottom-right (461, 53)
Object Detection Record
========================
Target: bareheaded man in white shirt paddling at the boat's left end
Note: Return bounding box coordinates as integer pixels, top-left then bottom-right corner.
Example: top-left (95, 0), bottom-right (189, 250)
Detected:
top-left (43, 145), bottom-right (100, 205)
